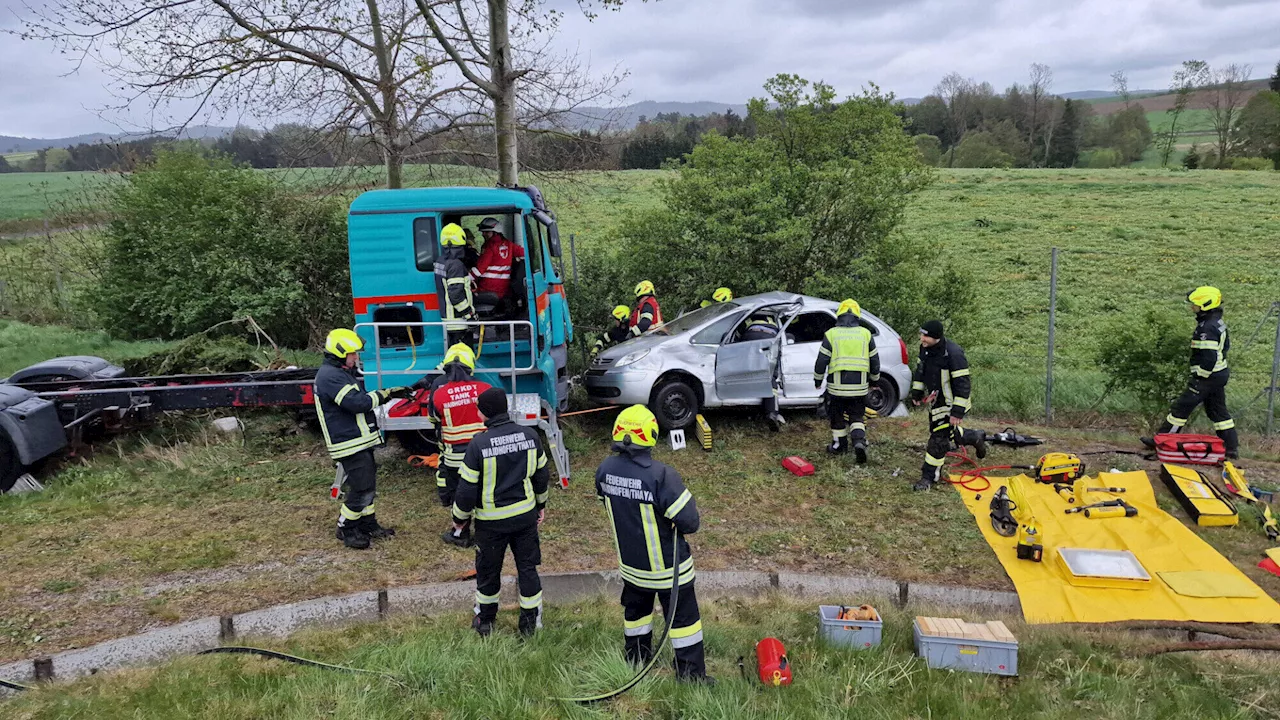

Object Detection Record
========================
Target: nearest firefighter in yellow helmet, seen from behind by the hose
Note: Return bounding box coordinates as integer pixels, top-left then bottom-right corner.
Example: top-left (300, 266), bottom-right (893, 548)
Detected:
top-left (595, 405), bottom-right (714, 683)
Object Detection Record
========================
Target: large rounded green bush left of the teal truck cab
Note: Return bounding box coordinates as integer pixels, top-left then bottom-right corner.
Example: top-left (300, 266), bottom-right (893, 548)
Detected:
top-left (86, 151), bottom-right (351, 347)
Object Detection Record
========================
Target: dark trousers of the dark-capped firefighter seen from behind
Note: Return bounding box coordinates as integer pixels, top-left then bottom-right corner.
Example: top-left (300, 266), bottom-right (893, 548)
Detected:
top-left (472, 514), bottom-right (543, 632)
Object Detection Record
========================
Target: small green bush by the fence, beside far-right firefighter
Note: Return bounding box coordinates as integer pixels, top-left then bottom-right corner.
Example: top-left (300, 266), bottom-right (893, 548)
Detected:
top-left (1097, 303), bottom-right (1192, 411)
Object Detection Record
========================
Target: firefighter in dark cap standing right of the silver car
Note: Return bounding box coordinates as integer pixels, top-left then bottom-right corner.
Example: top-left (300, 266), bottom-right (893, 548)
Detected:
top-left (910, 320), bottom-right (987, 491)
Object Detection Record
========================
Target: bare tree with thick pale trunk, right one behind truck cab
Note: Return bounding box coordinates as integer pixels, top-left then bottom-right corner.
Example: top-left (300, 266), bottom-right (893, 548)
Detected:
top-left (415, 0), bottom-right (625, 186)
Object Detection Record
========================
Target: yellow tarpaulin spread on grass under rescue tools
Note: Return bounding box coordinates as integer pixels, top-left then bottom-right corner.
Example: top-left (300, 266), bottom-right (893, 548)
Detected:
top-left (955, 471), bottom-right (1280, 624)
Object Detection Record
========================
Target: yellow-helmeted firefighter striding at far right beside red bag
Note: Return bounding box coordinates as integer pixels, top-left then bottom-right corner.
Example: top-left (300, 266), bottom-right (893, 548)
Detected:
top-left (1142, 286), bottom-right (1240, 459)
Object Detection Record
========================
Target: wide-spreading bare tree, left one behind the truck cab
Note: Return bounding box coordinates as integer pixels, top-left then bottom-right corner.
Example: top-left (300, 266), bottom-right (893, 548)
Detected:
top-left (23, 0), bottom-right (488, 187)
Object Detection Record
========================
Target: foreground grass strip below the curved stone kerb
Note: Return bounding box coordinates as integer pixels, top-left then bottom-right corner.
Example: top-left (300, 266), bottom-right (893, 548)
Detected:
top-left (4, 596), bottom-right (1276, 720)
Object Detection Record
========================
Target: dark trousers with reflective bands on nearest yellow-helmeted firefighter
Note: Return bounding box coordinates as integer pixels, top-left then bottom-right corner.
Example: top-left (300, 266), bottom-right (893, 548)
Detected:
top-left (622, 580), bottom-right (707, 678)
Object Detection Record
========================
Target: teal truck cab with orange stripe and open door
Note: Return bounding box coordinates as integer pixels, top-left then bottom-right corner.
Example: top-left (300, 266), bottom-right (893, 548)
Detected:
top-left (347, 187), bottom-right (573, 486)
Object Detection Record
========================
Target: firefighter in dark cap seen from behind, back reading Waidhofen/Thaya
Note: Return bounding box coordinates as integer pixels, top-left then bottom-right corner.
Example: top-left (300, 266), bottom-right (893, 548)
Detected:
top-left (453, 387), bottom-right (550, 637)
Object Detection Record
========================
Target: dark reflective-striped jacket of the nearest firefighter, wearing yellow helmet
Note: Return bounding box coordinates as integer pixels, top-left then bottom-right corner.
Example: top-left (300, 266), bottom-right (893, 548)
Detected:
top-left (595, 442), bottom-right (699, 591)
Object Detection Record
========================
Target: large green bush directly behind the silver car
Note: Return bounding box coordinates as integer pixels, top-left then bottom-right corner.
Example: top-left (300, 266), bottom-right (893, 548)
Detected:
top-left (604, 76), bottom-right (968, 328)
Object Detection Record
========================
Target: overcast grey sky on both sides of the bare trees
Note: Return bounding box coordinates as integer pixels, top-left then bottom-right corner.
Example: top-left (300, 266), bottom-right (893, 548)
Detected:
top-left (0, 0), bottom-right (1280, 137)
